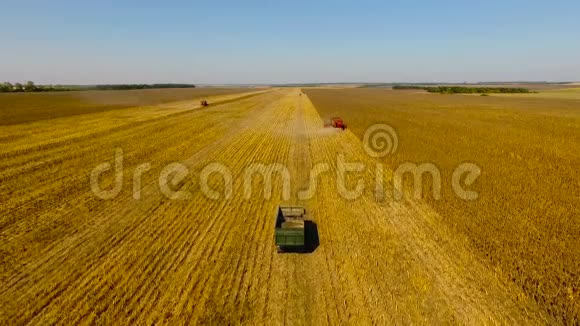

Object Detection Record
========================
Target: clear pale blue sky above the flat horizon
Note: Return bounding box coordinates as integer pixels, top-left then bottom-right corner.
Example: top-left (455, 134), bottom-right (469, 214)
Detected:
top-left (0, 0), bottom-right (580, 84)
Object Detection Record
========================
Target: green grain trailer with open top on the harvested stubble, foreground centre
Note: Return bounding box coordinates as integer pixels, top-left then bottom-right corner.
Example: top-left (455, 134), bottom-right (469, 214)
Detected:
top-left (274, 206), bottom-right (306, 252)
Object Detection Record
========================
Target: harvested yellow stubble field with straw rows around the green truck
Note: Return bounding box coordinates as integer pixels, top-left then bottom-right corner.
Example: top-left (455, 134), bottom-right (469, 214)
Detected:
top-left (0, 89), bottom-right (554, 325)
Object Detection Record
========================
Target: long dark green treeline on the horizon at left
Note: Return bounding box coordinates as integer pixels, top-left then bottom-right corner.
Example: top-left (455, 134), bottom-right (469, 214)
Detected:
top-left (0, 81), bottom-right (195, 93)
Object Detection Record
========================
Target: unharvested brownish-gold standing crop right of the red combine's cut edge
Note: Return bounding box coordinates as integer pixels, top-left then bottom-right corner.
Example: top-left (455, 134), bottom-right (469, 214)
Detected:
top-left (307, 89), bottom-right (580, 322)
